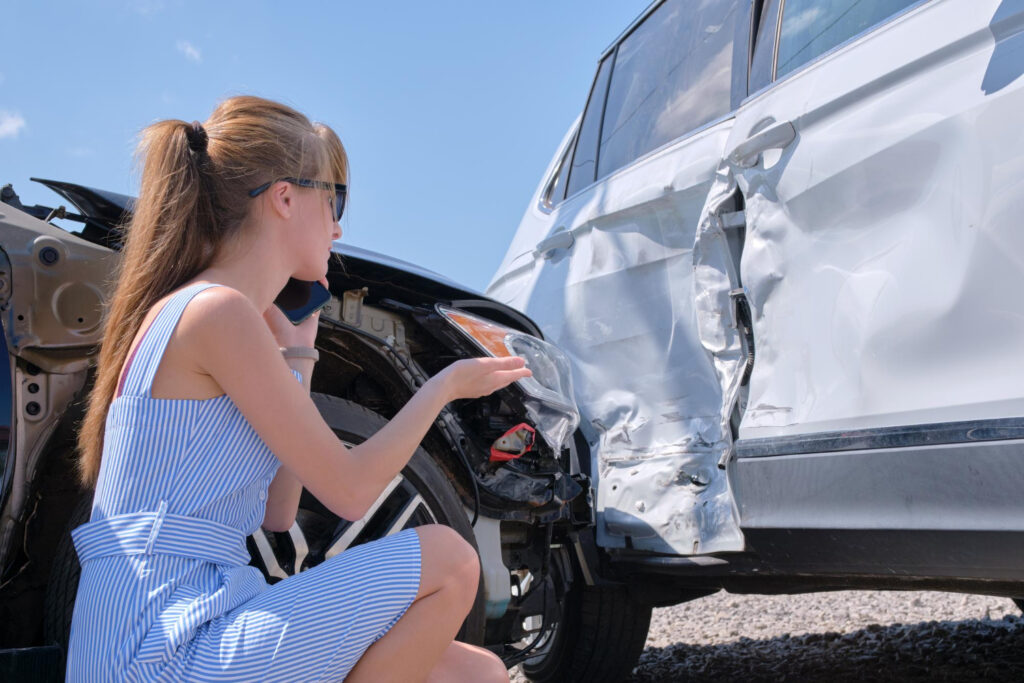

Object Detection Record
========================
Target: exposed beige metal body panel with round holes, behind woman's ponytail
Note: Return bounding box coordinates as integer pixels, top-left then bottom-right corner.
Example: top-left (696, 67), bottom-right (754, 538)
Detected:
top-left (0, 197), bottom-right (114, 573)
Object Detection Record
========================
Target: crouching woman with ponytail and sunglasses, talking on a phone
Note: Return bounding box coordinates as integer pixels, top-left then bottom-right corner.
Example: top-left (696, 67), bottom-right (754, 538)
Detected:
top-left (68, 96), bottom-right (530, 682)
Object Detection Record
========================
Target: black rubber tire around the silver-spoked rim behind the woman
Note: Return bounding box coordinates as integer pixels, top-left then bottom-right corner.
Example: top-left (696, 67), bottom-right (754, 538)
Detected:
top-left (43, 393), bottom-right (486, 671)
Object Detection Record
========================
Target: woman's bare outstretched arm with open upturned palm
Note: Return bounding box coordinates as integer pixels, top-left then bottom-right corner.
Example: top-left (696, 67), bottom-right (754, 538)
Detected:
top-left (178, 287), bottom-right (530, 522)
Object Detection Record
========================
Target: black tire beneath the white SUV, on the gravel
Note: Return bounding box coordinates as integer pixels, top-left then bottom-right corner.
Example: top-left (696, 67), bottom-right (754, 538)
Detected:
top-left (522, 548), bottom-right (651, 683)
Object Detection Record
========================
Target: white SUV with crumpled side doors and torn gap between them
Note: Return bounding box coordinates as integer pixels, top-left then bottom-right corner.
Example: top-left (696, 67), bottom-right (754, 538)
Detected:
top-left (486, 0), bottom-right (1024, 678)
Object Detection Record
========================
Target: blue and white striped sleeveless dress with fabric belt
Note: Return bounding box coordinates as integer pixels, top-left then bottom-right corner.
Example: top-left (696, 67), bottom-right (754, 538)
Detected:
top-left (67, 283), bottom-right (421, 682)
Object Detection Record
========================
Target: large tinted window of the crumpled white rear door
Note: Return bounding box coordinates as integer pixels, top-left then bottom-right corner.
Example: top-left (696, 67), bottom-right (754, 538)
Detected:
top-left (598, 0), bottom-right (740, 177)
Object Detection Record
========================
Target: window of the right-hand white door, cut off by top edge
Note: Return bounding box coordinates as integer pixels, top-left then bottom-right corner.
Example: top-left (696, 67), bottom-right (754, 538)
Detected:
top-left (775, 0), bottom-right (919, 78)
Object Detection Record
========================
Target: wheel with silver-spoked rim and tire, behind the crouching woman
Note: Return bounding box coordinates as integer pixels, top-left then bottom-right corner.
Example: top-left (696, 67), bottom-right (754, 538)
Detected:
top-left (43, 393), bottom-right (486, 667)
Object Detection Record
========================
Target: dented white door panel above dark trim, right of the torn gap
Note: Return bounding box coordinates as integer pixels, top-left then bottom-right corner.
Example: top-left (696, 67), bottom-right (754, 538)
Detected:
top-left (729, 2), bottom-right (1024, 438)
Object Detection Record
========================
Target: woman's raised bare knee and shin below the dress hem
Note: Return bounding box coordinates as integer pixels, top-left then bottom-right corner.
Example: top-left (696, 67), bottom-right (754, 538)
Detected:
top-left (345, 524), bottom-right (508, 683)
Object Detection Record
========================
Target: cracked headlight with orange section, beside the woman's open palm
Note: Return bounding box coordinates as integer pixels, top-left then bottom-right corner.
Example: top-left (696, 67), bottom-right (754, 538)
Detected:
top-left (437, 304), bottom-right (580, 454)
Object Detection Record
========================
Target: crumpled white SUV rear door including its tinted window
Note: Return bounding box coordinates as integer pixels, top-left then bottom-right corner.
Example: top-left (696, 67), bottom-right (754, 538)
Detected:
top-left (487, 0), bottom-right (750, 554)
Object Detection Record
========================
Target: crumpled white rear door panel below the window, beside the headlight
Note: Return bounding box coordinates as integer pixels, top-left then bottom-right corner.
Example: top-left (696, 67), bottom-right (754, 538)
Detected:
top-left (487, 120), bottom-right (741, 554)
